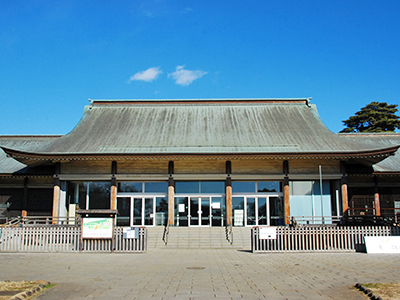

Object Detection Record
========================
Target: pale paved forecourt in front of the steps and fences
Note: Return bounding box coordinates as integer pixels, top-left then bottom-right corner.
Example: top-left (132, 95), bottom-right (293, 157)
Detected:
top-left (0, 249), bottom-right (400, 300)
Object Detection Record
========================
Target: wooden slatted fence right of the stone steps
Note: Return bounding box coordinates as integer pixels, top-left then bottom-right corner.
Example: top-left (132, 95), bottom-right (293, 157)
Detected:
top-left (251, 226), bottom-right (400, 253)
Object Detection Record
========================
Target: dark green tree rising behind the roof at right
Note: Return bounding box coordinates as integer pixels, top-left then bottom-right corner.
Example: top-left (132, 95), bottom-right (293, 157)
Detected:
top-left (340, 102), bottom-right (400, 132)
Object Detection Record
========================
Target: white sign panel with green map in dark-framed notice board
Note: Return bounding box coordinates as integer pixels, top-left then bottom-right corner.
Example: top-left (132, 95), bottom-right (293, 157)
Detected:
top-left (82, 218), bottom-right (114, 239)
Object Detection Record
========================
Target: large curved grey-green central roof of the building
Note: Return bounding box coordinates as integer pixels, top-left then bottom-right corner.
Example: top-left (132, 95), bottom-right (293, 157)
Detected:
top-left (0, 99), bottom-right (398, 162)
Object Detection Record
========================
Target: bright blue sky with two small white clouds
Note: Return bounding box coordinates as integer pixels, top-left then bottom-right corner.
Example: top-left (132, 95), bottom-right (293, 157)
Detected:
top-left (0, 0), bottom-right (400, 134)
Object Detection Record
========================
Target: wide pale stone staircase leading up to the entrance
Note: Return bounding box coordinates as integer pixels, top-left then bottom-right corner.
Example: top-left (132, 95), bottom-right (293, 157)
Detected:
top-left (147, 226), bottom-right (251, 250)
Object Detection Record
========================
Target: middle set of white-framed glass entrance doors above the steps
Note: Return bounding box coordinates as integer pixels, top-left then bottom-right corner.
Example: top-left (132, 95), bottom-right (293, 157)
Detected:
top-left (175, 196), bottom-right (225, 227)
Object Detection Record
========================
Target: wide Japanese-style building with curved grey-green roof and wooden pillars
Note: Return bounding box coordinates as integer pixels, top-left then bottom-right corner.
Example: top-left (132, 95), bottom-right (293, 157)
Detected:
top-left (0, 99), bottom-right (400, 226)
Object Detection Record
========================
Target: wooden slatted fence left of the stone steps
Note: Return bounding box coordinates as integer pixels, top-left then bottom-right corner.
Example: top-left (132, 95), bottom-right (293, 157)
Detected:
top-left (0, 225), bottom-right (147, 252)
